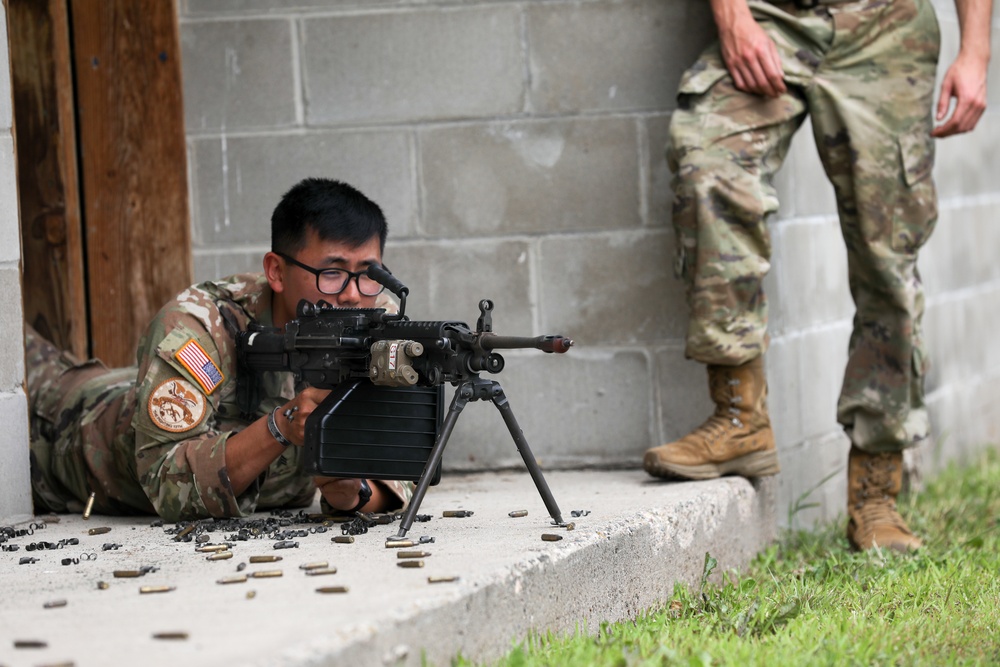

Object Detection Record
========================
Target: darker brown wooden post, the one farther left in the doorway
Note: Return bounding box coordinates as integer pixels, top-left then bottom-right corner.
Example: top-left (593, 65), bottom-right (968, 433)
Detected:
top-left (7, 0), bottom-right (89, 357)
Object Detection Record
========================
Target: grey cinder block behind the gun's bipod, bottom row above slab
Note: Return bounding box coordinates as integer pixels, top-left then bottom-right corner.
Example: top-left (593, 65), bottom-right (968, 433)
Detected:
top-left (445, 347), bottom-right (653, 470)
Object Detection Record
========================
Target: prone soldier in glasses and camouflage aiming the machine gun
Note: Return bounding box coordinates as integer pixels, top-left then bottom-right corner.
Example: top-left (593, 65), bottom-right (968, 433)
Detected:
top-left (25, 178), bottom-right (412, 521)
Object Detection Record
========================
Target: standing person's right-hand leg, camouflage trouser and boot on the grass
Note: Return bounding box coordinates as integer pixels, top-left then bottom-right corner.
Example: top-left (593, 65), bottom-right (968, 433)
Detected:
top-left (809, 0), bottom-right (938, 550)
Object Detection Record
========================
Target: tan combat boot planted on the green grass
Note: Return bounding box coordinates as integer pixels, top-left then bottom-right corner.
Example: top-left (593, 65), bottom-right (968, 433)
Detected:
top-left (847, 445), bottom-right (922, 551)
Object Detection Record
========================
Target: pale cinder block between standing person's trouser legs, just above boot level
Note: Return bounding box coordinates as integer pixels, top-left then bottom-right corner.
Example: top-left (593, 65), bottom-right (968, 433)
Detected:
top-left (771, 218), bottom-right (854, 330)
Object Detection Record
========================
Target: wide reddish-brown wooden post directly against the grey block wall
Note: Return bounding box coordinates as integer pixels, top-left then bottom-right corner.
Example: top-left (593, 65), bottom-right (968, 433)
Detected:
top-left (70, 0), bottom-right (192, 366)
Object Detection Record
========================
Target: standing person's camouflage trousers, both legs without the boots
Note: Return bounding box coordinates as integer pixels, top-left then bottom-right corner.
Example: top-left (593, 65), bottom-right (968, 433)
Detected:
top-left (668, 0), bottom-right (940, 451)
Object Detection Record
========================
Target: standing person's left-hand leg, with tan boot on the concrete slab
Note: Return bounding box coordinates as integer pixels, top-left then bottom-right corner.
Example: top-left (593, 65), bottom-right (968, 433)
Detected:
top-left (643, 3), bottom-right (829, 479)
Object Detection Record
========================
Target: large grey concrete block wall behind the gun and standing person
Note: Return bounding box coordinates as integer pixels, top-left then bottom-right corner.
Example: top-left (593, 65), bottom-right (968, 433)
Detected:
top-left (180, 0), bottom-right (1000, 524)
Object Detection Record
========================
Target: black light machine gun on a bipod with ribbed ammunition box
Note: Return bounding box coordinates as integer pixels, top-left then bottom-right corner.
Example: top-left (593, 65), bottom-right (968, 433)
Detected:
top-left (236, 265), bottom-right (573, 539)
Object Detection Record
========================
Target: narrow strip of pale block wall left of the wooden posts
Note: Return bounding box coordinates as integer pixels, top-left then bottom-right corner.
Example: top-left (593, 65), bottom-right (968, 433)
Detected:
top-left (0, 4), bottom-right (31, 523)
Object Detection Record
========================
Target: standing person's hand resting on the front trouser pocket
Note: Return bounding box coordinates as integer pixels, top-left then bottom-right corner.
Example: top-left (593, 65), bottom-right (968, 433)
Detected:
top-left (713, 3), bottom-right (788, 97)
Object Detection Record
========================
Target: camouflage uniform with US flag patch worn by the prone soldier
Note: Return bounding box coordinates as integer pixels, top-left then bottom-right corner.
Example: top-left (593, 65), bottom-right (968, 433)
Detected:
top-left (26, 274), bottom-right (411, 521)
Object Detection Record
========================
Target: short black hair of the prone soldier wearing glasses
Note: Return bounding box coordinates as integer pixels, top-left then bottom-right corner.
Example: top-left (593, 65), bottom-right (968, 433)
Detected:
top-left (271, 178), bottom-right (388, 255)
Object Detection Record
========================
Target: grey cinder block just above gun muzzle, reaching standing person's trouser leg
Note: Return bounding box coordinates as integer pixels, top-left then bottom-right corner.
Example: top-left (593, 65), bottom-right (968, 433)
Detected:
top-left (539, 231), bottom-right (687, 345)
